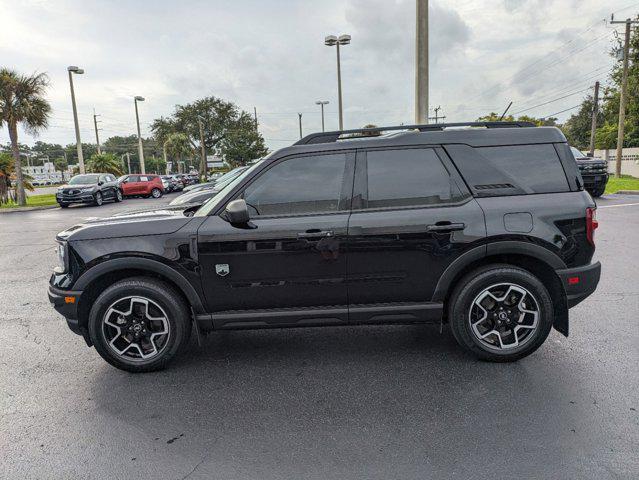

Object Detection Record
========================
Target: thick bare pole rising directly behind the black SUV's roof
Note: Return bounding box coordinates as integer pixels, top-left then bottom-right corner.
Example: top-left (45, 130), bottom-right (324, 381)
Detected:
top-left (415, 0), bottom-right (428, 124)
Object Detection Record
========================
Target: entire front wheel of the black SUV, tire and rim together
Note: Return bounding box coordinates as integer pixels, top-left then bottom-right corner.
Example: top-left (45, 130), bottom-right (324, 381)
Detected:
top-left (88, 277), bottom-right (191, 373)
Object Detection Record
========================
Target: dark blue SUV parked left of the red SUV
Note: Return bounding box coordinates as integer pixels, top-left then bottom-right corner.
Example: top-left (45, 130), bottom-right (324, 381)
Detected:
top-left (55, 173), bottom-right (122, 208)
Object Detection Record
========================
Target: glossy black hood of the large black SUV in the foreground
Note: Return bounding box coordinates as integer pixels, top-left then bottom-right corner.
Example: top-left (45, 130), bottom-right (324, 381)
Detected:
top-left (57, 205), bottom-right (192, 241)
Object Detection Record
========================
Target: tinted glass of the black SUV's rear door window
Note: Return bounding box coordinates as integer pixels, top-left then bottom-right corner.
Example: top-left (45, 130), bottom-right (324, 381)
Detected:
top-left (366, 148), bottom-right (462, 208)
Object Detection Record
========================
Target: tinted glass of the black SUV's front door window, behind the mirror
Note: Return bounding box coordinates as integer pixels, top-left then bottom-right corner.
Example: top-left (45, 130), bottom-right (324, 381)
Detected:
top-left (244, 154), bottom-right (346, 215)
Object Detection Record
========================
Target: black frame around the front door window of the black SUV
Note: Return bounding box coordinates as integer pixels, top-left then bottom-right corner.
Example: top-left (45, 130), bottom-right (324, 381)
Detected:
top-left (232, 149), bottom-right (356, 220)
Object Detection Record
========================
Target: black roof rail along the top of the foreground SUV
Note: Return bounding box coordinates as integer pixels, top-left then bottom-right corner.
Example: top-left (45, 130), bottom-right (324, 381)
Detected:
top-left (293, 122), bottom-right (536, 145)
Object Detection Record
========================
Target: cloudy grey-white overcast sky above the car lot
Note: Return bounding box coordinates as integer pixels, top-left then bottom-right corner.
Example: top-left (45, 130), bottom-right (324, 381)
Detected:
top-left (0, 0), bottom-right (639, 152)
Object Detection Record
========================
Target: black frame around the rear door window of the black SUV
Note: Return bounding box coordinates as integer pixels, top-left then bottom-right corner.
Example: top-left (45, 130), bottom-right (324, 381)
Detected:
top-left (351, 145), bottom-right (473, 213)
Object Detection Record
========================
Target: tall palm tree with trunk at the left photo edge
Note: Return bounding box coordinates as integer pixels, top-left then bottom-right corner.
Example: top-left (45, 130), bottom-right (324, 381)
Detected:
top-left (0, 68), bottom-right (51, 205)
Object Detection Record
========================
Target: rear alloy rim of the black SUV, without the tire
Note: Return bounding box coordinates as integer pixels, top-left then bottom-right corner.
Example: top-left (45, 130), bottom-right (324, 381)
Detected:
top-left (468, 283), bottom-right (539, 350)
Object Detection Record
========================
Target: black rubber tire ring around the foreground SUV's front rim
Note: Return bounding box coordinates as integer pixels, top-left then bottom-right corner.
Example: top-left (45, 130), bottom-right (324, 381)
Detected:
top-left (88, 277), bottom-right (191, 373)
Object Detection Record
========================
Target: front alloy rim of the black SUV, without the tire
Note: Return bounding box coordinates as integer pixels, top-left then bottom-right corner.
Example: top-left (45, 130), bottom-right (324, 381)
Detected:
top-left (102, 296), bottom-right (171, 361)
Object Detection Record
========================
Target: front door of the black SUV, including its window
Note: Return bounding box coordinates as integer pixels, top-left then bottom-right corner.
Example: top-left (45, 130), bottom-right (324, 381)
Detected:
top-left (198, 153), bottom-right (355, 328)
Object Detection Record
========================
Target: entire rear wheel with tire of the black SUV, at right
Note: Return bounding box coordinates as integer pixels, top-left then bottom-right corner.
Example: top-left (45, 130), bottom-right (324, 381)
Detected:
top-left (448, 265), bottom-right (553, 362)
